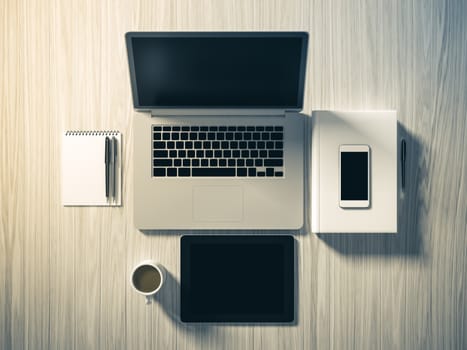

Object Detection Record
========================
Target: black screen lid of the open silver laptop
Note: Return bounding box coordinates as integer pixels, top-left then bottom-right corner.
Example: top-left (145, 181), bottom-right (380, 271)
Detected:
top-left (126, 32), bottom-right (308, 109)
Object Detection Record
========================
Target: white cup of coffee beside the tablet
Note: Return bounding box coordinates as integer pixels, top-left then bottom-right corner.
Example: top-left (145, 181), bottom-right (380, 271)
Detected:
top-left (130, 260), bottom-right (165, 304)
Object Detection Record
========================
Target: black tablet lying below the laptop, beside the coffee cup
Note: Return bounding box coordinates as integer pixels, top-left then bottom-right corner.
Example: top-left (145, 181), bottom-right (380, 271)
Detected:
top-left (181, 235), bottom-right (295, 323)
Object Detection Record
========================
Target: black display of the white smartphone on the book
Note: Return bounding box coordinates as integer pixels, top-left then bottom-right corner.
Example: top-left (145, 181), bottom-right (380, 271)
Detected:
top-left (341, 152), bottom-right (368, 201)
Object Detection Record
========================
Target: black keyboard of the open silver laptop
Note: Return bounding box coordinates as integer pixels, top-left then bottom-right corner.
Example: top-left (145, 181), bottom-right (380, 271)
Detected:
top-left (152, 125), bottom-right (284, 177)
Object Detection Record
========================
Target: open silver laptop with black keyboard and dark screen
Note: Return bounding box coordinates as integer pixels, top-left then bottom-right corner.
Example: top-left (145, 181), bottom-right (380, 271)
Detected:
top-left (126, 32), bottom-right (308, 230)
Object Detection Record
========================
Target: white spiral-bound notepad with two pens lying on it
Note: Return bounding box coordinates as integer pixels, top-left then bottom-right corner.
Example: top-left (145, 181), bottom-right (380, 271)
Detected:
top-left (62, 131), bottom-right (122, 206)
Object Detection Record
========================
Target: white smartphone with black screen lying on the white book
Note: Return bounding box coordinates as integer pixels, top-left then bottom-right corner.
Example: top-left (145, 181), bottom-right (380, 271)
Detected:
top-left (339, 145), bottom-right (370, 208)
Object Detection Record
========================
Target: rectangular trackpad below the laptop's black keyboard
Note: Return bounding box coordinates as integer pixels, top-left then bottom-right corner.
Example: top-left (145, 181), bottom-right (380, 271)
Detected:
top-left (193, 186), bottom-right (243, 222)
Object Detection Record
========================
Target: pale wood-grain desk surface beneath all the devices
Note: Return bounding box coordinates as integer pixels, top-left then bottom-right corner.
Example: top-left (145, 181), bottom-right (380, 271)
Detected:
top-left (0, 0), bottom-right (467, 350)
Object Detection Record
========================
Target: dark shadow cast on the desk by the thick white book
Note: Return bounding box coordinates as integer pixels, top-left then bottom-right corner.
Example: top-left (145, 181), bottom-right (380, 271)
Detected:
top-left (318, 123), bottom-right (428, 257)
